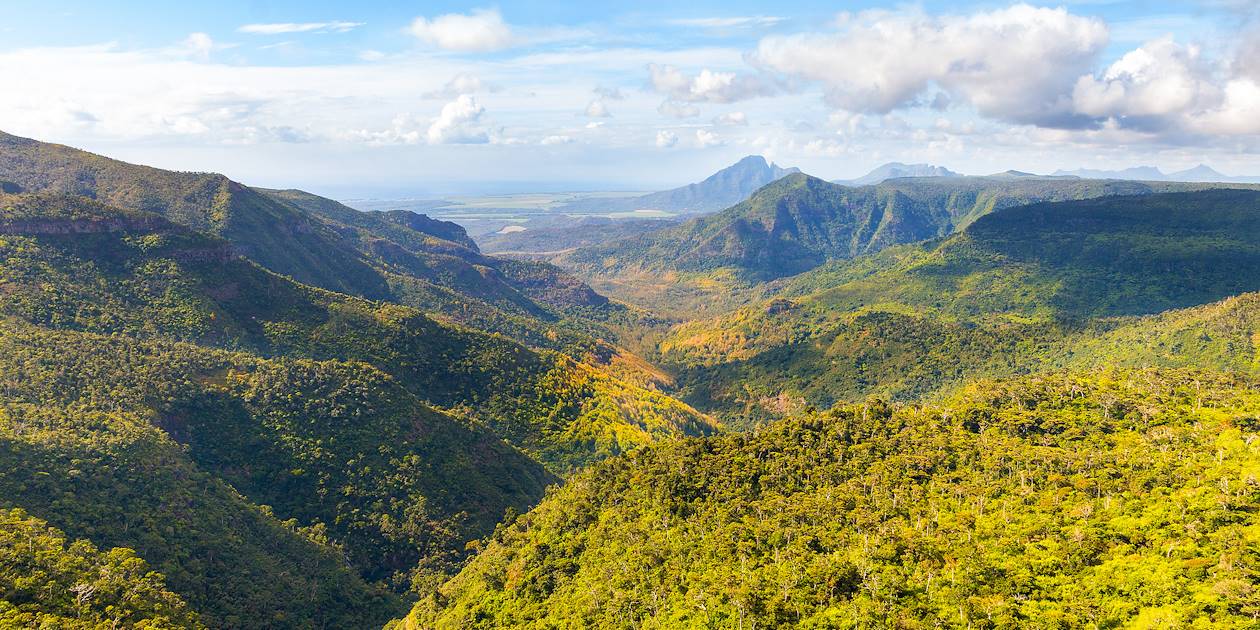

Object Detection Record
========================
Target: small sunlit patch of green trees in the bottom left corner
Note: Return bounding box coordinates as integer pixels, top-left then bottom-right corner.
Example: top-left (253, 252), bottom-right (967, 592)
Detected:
top-left (0, 509), bottom-right (204, 630)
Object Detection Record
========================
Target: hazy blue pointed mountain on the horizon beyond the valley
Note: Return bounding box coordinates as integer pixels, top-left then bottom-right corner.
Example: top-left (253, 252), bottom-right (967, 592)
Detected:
top-left (558, 155), bottom-right (800, 214)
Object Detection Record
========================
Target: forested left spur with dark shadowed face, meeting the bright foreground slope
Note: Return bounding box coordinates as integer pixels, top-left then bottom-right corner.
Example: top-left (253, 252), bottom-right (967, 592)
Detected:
top-left (0, 325), bottom-right (556, 597)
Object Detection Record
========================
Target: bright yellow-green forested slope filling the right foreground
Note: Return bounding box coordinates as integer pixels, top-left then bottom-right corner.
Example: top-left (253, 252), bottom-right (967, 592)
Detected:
top-left (399, 370), bottom-right (1260, 629)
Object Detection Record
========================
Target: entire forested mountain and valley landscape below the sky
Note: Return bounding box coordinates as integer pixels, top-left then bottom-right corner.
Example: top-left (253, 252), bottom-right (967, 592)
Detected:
top-left (0, 134), bottom-right (1260, 630)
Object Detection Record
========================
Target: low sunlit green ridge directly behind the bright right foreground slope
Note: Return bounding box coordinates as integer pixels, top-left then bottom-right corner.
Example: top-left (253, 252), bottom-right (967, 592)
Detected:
top-left (667, 294), bottom-right (1260, 427)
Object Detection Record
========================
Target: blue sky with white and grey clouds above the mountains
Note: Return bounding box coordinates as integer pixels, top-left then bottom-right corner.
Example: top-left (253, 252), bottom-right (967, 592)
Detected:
top-left (0, 0), bottom-right (1260, 198)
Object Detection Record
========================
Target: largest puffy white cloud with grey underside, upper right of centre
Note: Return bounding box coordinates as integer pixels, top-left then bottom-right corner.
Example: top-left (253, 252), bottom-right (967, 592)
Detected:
top-left (752, 4), bottom-right (1108, 126)
